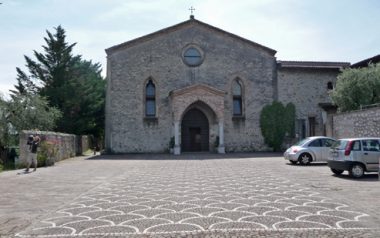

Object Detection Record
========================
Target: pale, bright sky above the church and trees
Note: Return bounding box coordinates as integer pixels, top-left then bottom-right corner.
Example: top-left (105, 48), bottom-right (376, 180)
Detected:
top-left (0, 0), bottom-right (380, 94)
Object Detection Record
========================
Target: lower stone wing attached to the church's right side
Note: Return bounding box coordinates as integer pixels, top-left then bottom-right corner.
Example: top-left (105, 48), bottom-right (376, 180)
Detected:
top-left (277, 61), bottom-right (349, 138)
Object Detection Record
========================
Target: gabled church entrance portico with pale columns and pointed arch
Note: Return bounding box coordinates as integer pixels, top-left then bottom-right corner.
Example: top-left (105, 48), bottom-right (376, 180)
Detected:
top-left (170, 84), bottom-right (225, 155)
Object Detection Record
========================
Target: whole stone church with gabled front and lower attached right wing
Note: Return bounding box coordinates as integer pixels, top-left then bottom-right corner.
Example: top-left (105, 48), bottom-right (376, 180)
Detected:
top-left (106, 17), bottom-right (349, 154)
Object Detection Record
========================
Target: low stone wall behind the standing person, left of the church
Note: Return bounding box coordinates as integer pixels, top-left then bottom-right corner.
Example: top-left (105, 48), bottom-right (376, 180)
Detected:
top-left (19, 131), bottom-right (90, 164)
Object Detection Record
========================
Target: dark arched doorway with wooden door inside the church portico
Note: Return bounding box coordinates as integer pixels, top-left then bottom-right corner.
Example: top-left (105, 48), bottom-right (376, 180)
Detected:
top-left (181, 108), bottom-right (210, 152)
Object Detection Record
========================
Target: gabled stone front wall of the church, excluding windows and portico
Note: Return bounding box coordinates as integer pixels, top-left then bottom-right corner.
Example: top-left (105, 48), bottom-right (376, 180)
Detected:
top-left (106, 21), bottom-right (276, 153)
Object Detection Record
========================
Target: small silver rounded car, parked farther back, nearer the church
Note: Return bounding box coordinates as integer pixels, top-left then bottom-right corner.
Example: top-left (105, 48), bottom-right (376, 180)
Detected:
top-left (284, 136), bottom-right (336, 165)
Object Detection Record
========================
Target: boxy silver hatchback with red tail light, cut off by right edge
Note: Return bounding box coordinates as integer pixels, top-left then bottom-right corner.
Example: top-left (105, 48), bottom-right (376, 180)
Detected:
top-left (327, 138), bottom-right (380, 178)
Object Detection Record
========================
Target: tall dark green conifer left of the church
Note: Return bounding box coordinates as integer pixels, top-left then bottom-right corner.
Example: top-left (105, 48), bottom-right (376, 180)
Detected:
top-left (12, 26), bottom-right (105, 137)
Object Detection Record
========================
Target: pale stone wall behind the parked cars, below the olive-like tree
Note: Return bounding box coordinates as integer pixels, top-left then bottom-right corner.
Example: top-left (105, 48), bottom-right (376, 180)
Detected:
top-left (333, 107), bottom-right (380, 138)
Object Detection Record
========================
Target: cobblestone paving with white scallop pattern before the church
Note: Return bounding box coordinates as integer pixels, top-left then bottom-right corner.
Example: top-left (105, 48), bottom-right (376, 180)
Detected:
top-left (7, 154), bottom-right (379, 237)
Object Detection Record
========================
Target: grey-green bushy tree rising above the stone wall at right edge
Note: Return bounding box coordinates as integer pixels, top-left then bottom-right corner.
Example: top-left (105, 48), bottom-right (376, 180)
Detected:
top-left (331, 64), bottom-right (380, 112)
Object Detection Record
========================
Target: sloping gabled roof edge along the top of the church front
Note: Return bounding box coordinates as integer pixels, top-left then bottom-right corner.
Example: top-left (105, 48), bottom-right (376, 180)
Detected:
top-left (105, 16), bottom-right (277, 56)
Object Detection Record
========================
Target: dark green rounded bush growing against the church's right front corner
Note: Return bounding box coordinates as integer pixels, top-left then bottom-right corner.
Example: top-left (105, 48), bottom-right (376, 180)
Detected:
top-left (260, 101), bottom-right (295, 151)
